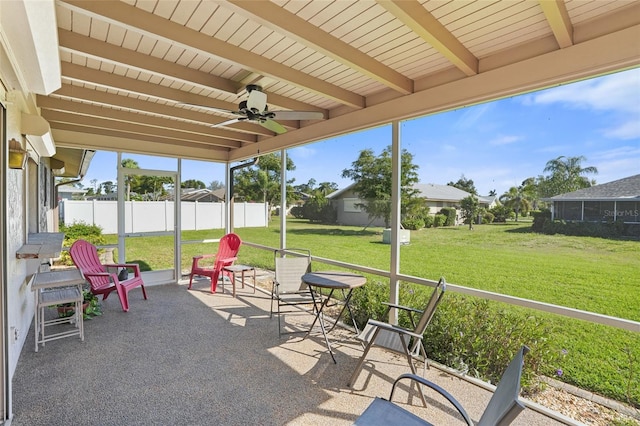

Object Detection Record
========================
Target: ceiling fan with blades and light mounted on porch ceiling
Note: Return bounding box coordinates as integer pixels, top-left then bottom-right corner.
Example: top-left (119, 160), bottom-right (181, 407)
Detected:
top-left (194, 84), bottom-right (324, 134)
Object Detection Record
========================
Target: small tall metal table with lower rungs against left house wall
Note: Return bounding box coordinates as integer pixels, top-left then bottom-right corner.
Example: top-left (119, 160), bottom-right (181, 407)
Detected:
top-left (31, 269), bottom-right (85, 352)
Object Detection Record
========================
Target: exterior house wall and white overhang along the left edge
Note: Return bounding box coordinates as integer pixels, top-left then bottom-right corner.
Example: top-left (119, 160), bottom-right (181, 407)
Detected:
top-left (0, 0), bottom-right (61, 423)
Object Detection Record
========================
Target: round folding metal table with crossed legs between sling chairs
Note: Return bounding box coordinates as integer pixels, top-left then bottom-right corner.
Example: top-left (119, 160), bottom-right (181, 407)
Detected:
top-left (302, 271), bottom-right (367, 364)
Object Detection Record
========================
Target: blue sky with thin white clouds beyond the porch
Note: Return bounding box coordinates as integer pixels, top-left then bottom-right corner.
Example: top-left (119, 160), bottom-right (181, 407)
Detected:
top-left (82, 68), bottom-right (640, 195)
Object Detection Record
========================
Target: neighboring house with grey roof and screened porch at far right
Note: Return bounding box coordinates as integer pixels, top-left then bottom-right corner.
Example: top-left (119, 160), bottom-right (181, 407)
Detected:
top-left (542, 175), bottom-right (640, 224)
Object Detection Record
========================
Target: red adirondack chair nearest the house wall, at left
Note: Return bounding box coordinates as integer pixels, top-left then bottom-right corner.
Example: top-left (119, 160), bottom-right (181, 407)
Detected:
top-left (69, 240), bottom-right (147, 312)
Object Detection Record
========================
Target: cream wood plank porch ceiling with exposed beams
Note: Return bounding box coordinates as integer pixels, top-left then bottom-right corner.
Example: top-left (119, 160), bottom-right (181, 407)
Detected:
top-left (42, 0), bottom-right (640, 161)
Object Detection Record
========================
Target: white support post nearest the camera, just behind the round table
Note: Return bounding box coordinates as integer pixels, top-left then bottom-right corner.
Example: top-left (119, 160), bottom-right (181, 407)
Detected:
top-left (389, 120), bottom-right (402, 324)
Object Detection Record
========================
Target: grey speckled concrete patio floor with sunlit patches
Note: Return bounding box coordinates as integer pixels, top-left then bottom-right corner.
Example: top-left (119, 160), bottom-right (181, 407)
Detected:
top-left (11, 274), bottom-right (561, 426)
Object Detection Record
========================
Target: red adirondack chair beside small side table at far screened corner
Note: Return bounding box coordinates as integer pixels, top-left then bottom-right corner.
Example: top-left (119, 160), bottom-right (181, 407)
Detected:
top-left (189, 233), bottom-right (242, 293)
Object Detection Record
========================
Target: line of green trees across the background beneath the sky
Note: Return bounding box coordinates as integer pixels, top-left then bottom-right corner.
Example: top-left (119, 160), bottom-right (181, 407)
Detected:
top-left (61, 151), bottom-right (598, 228)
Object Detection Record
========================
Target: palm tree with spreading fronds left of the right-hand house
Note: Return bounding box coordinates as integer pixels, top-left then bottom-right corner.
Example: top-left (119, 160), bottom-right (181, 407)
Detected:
top-left (544, 155), bottom-right (598, 197)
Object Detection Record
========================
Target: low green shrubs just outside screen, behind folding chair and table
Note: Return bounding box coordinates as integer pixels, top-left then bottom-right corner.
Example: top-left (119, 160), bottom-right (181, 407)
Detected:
top-left (351, 281), bottom-right (560, 392)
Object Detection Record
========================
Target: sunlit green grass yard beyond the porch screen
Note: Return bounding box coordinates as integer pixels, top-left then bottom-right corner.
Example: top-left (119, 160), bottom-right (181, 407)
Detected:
top-left (107, 219), bottom-right (640, 407)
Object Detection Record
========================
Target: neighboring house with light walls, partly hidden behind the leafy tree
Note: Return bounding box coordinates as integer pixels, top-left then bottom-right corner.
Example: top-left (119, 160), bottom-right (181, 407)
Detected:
top-left (327, 183), bottom-right (497, 226)
